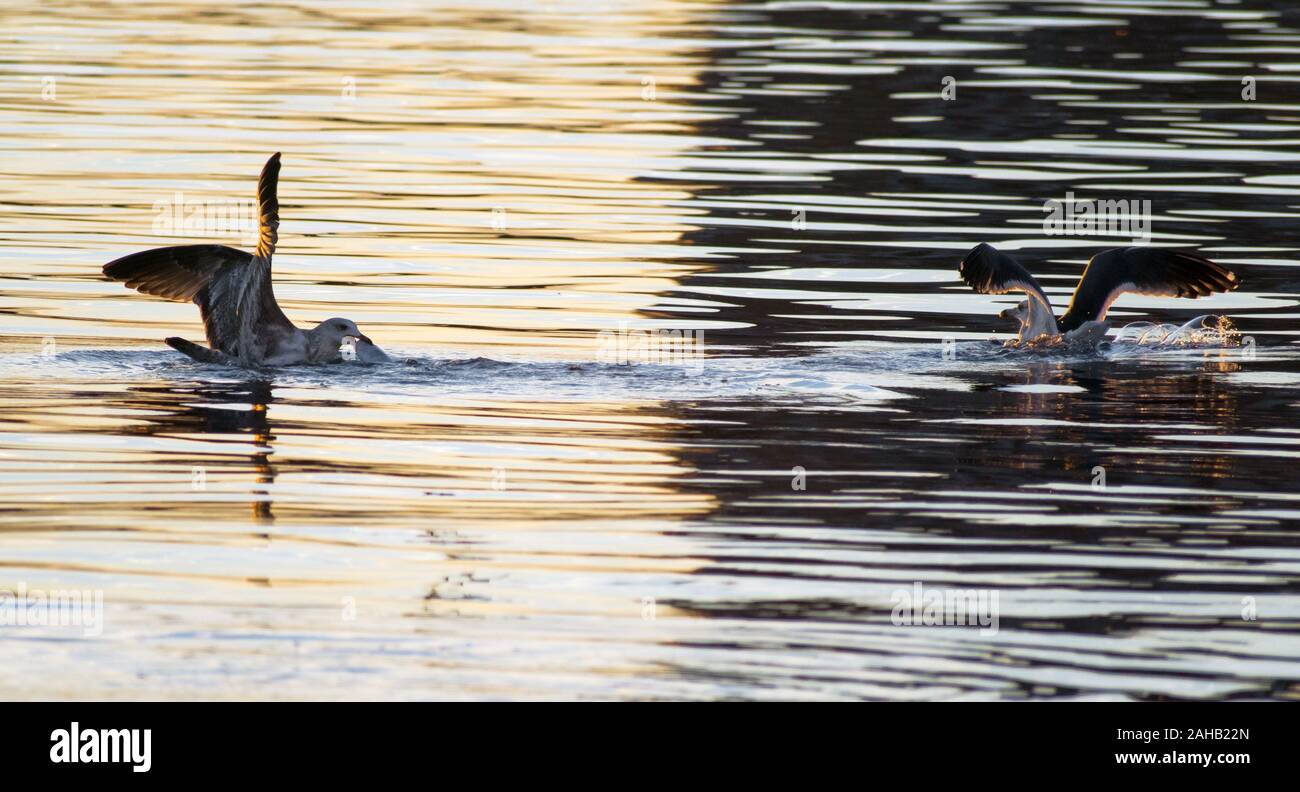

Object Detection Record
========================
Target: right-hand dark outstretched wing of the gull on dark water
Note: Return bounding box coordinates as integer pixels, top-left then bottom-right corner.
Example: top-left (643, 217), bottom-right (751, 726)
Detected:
top-left (1061, 247), bottom-right (1240, 332)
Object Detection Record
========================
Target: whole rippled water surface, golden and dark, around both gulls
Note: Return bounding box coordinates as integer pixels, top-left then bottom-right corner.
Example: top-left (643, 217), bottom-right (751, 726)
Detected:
top-left (0, 0), bottom-right (1300, 698)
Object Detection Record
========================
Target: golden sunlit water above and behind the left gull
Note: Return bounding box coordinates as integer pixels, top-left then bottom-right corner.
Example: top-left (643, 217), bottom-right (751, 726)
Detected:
top-left (0, 1), bottom-right (733, 359)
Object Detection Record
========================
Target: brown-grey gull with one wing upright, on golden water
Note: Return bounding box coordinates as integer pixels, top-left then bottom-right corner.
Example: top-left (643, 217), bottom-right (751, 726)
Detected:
top-left (104, 152), bottom-right (384, 368)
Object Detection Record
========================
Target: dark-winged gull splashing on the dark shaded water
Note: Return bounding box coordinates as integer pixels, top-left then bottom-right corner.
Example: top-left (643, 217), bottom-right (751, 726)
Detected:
top-left (958, 242), bottom-right (1242, 342)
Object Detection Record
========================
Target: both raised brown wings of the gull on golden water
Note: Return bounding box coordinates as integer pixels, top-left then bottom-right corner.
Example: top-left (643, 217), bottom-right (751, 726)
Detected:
top-left (104, 153), bottom-right (294, 365)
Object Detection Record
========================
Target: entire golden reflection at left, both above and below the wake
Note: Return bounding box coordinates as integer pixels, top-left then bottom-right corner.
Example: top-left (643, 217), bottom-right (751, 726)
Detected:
top-left (0, 1), bottom-right (733, 697)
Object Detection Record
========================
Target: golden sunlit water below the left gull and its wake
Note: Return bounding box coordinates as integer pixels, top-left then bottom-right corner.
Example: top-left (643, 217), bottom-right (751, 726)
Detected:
top-left (0, 366), bottom-right (714, 697)
